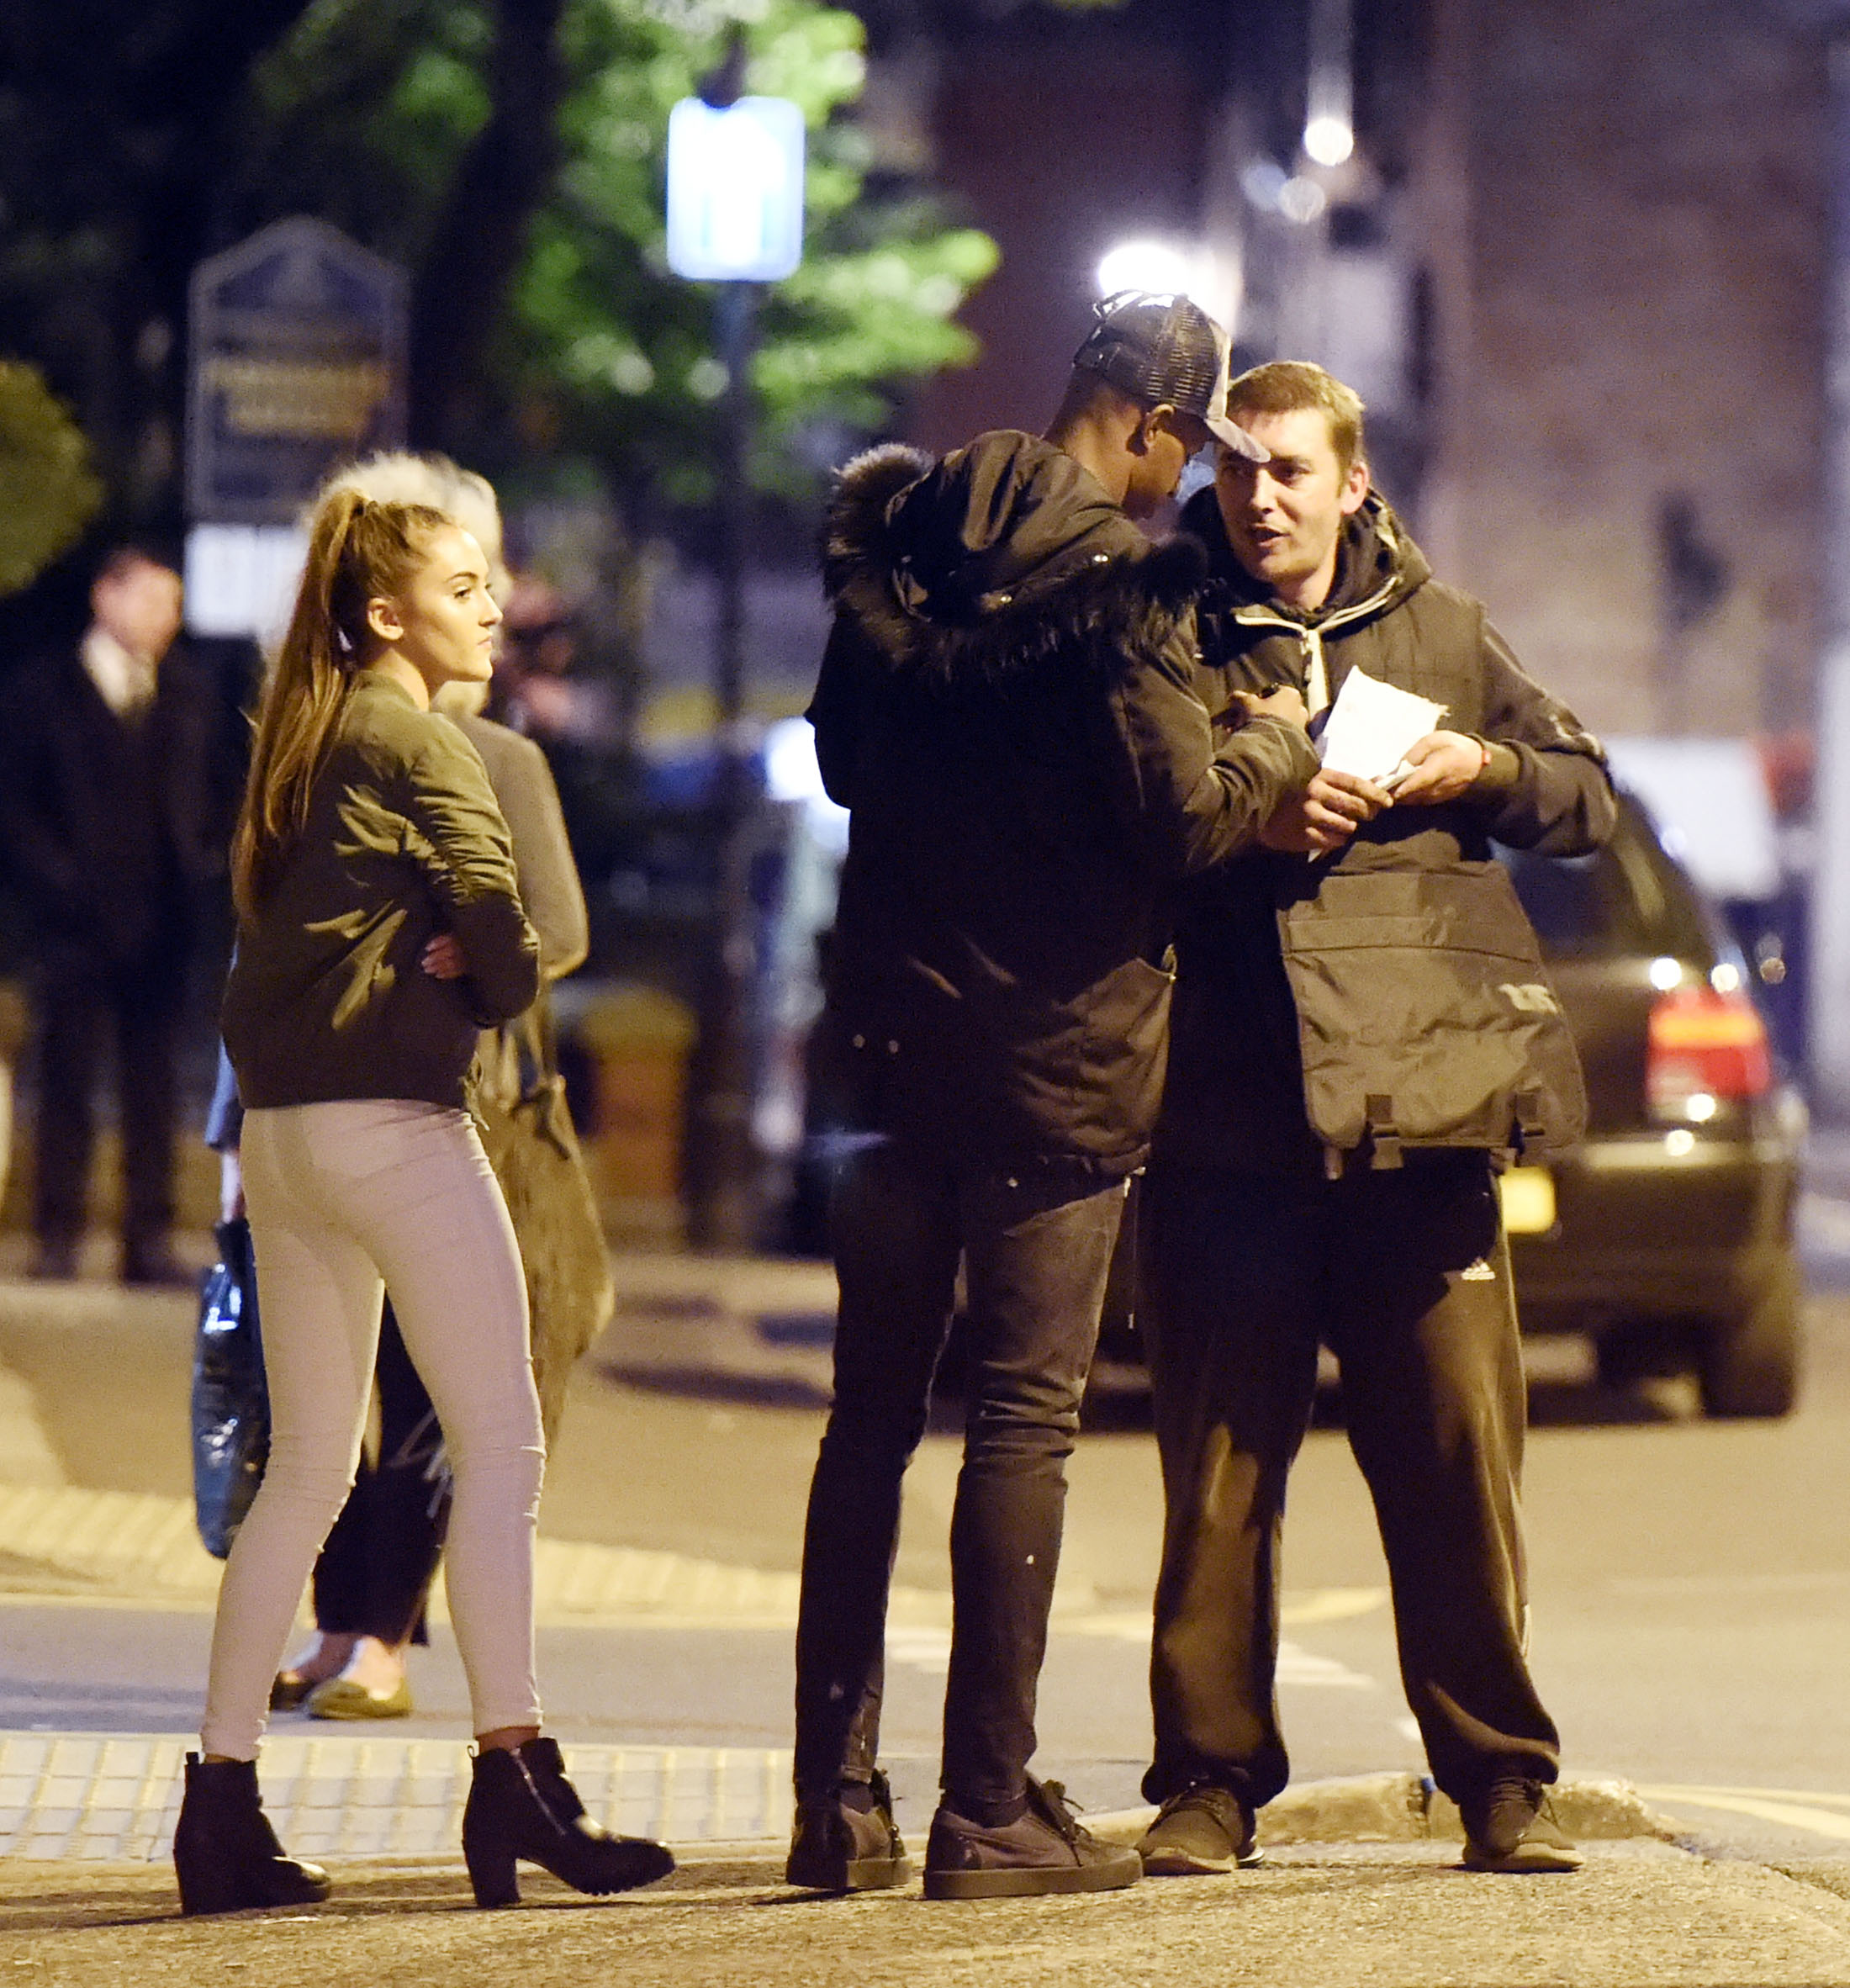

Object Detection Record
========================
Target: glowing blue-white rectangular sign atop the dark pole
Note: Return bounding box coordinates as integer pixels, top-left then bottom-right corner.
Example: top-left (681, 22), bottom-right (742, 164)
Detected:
top-left (668, 98), bottom-right (803, 283)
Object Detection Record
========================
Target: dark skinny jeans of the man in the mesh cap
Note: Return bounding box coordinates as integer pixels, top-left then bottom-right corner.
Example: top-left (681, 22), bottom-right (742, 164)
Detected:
top-left (795, 1145), bottom-right (1124, 1813)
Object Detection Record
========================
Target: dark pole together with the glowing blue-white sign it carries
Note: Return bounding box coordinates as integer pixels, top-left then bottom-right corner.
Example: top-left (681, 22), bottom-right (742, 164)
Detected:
top-left (668, 58), bottom-right (803, 1250)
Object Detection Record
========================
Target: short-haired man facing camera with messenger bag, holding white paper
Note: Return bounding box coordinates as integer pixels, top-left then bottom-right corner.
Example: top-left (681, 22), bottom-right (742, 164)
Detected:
top-left (1139, 362), bottom-right (1614, 1874)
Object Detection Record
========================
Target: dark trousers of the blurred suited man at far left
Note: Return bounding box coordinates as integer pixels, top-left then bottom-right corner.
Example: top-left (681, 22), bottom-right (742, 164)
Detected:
top-left (34, 956), bottom-right (185, 1255)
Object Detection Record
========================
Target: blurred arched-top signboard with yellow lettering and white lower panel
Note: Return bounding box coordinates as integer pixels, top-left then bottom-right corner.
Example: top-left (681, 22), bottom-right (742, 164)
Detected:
top-left (187, 217), bottom-right (407, 634)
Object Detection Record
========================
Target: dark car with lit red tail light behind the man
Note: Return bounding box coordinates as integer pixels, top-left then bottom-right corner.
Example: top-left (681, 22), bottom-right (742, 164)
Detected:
top-left (1502, 796), bottom-right (1806, 1415)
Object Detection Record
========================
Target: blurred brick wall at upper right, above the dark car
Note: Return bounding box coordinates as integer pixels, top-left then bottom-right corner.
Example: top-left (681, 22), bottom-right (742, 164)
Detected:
top-left (1407, 0), bottom-right (1828, 736)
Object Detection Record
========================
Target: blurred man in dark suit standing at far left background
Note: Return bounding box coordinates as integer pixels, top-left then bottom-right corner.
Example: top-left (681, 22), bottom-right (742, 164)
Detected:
top-left (0, 547), bottom-right (223, 1284)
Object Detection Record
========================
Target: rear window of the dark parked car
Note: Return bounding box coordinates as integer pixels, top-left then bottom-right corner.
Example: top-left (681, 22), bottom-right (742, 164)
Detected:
top-left (1496, 805), bottom-right (1715, 965)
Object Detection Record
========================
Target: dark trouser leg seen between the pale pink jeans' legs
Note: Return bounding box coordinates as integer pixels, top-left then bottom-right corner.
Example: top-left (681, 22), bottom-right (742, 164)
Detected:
top-left (314, 1300), bottom-right (449, 1644)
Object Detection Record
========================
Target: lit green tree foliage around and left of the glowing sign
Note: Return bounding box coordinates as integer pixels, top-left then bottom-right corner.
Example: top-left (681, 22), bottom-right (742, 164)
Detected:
top-left (245, 0), bottom-right (996, 505)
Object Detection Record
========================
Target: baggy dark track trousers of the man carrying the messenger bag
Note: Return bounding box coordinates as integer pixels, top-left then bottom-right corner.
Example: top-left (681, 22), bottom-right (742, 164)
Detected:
top-left (1139, 1153), bottom-right (1560, 1806)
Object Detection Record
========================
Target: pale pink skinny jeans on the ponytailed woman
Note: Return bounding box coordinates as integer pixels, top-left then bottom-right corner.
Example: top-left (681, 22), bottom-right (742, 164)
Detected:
top-left (198, 1099), bottom-right (547, 1759)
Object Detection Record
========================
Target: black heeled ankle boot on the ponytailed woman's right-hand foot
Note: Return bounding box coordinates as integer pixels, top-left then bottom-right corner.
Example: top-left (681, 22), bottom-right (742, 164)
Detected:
top-left (463, 1740), bottom-right (674, 1905)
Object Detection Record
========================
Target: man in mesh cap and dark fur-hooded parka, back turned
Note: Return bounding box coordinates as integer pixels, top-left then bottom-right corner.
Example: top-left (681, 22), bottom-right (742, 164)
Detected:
top-left (787, 296), bottom-right (1315, 1896)
